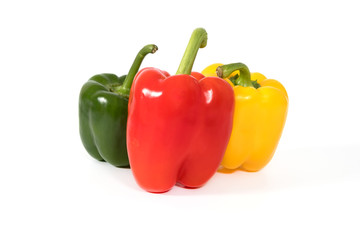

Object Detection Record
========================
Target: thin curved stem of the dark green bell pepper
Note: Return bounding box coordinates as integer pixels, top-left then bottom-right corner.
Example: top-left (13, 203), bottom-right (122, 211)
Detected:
top-left (114, 44), bottom-right (158, 96)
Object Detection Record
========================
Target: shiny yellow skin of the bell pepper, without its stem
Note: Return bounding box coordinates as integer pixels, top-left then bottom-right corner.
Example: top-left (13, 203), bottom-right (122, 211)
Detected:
top-left (202, 64), bottom-right (288, 172)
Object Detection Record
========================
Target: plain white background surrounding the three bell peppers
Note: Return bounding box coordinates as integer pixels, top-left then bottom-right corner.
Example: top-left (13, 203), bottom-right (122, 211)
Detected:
top-left (0, 0), bottom-right (360, 239)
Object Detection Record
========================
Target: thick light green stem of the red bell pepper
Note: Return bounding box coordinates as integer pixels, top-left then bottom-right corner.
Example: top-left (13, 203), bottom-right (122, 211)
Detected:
top-left (176, 28), bottom-right (207, 75)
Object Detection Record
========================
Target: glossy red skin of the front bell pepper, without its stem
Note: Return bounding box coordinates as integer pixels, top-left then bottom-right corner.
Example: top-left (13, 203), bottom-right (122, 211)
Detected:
top-left (127, 68), bottom-right (234, 193)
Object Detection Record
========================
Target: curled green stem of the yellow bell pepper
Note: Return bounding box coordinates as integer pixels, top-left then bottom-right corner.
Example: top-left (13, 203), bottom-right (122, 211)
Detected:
top-left (216, 63), bottom-right (254, 87)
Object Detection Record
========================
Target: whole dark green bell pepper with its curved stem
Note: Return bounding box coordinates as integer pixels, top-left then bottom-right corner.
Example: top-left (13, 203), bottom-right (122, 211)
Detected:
top-left (79, 44), bottom-right (157, 167)
